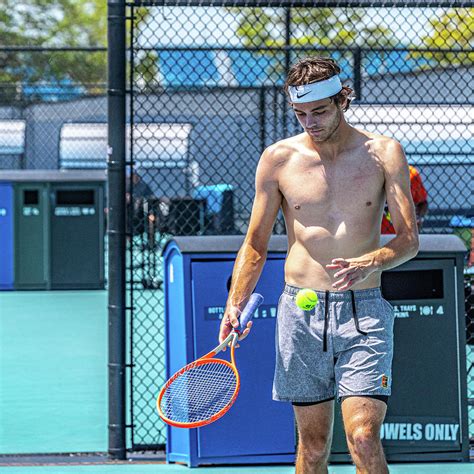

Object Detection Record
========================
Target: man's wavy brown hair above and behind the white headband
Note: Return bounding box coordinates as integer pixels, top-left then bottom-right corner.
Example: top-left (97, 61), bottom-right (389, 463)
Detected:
top-left (285, 56), bottom-right (354, 112)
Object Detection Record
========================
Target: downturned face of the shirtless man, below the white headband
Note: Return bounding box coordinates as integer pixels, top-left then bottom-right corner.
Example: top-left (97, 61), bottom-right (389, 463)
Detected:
top-left (292, 98), bottom-right (342, 142)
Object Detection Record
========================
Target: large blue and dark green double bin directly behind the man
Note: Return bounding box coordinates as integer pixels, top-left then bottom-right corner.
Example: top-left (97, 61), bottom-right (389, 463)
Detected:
top-left (164, 235), bottom-right (469, 465)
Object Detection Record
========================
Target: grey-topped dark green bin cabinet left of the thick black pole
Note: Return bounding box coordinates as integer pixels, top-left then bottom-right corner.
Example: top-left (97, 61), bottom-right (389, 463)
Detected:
top-left (0, 170), bottom-right (106, 290)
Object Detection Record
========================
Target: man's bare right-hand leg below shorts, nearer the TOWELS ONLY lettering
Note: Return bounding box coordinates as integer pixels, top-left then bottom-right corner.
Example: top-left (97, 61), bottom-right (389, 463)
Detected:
top-left (342, 396), bottom-right (388, 474)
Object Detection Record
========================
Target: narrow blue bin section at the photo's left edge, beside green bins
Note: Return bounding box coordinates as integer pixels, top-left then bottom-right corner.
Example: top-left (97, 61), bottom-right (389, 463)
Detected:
top-left (0, 182), bottom-right (15, 290)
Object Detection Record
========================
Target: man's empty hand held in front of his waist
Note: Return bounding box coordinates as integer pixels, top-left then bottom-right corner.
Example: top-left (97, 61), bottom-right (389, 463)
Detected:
top-left (326, 257), bottom-right (377, 291)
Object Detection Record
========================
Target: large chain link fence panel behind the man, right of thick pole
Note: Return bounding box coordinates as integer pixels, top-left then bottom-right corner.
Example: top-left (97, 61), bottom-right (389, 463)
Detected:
top-left (129, 1), bottom-right (474, 449)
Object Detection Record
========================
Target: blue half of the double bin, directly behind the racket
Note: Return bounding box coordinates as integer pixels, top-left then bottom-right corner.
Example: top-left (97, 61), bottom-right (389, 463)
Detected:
top-left (164, 236), bottom-right (295, 466)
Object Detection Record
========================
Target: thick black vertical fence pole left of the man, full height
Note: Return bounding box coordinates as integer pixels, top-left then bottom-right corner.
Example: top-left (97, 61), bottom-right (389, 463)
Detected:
top-left (107, 0), bottom-right (126, 459)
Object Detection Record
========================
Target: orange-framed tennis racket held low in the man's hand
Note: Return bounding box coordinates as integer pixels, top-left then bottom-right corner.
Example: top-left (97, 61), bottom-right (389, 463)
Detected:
top-left (156, 293), bottom-right (263, 428)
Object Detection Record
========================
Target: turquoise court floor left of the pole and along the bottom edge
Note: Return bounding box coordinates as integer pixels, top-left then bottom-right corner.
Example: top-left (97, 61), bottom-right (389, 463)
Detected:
top-left (0, 291), bottom-right (474, 474)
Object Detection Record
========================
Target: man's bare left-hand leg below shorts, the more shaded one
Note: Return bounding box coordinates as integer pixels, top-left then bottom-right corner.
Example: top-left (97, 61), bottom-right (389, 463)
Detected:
top-left (293, 400), bottom-right (334, 474)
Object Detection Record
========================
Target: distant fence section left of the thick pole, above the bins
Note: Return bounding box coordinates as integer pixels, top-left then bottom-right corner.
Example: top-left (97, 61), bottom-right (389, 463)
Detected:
top-left (0, 46), bottom-right (107, 170)
